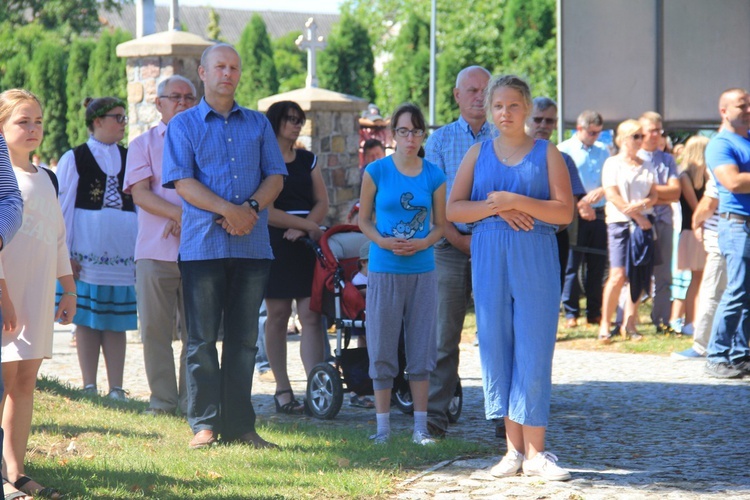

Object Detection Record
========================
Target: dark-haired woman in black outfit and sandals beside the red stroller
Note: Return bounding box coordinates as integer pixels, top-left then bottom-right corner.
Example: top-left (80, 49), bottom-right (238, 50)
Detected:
top-left (266, 101), bottom-right (328, 415)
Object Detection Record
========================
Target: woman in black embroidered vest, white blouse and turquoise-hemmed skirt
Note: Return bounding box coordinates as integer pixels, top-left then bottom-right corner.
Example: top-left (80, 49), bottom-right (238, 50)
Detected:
top-left (57, 97), bottom-right (138, 400)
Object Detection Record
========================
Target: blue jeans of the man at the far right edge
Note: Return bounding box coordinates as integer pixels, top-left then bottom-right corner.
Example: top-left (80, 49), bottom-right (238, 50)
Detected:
top-left (707, 219), bottom-right (750, 363)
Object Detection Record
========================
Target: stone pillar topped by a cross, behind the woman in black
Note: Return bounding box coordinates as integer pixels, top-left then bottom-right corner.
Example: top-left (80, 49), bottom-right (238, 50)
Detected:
top-left (258, 87), bottom-right (368, 225)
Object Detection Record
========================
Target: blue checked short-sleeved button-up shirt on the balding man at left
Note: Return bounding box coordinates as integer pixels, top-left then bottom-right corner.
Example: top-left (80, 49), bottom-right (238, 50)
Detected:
top-left (162, 99), bottom-right (287, 261)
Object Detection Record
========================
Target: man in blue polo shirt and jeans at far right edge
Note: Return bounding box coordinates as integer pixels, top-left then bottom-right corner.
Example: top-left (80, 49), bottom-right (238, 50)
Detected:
top-left (705, 89), bottom-right (750, 378)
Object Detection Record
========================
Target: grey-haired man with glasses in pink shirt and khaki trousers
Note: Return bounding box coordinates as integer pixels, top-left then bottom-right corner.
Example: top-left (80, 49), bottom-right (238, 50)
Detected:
top-left (124, 75), bottom-right (198, 415)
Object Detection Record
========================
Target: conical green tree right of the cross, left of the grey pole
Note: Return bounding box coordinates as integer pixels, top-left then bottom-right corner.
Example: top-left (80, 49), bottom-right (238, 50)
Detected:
top-left (375, 12), bottom-right (430, 113)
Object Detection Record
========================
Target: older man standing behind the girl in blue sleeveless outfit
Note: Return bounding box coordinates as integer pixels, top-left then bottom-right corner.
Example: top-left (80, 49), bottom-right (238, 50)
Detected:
top-left (425, 66), bottom-right (497, 437)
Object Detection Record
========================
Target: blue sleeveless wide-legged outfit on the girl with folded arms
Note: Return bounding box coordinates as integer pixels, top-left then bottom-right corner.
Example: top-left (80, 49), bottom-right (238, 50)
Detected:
top-left (471, 140), bottom-right (560, 427)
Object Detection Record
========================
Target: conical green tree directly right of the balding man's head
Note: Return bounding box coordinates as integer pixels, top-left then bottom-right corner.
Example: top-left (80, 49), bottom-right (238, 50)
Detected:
top-left (237, 14), bottom-right (279, 109)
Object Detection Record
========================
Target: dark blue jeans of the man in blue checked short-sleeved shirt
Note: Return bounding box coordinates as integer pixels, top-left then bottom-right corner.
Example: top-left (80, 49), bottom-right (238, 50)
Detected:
top-left (180, 259), bottom-right (271, 441)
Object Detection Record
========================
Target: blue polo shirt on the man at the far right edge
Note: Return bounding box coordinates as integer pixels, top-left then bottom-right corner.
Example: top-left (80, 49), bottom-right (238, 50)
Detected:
top-left (706, 130), bottom-right (750, 216)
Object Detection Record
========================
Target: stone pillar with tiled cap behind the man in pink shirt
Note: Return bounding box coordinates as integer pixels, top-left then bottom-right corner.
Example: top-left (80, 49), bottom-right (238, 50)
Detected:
top-left (117, 31), bottom-right (214, 142)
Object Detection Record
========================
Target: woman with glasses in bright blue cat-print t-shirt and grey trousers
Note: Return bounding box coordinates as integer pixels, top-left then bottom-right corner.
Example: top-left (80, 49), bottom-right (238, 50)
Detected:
top-left (359, 104), bottom-right (445, 445)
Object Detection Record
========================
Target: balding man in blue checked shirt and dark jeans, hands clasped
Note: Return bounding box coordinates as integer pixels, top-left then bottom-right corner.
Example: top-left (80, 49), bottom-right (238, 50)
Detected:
top-left (162, 43), bottom-right (287, 448)
